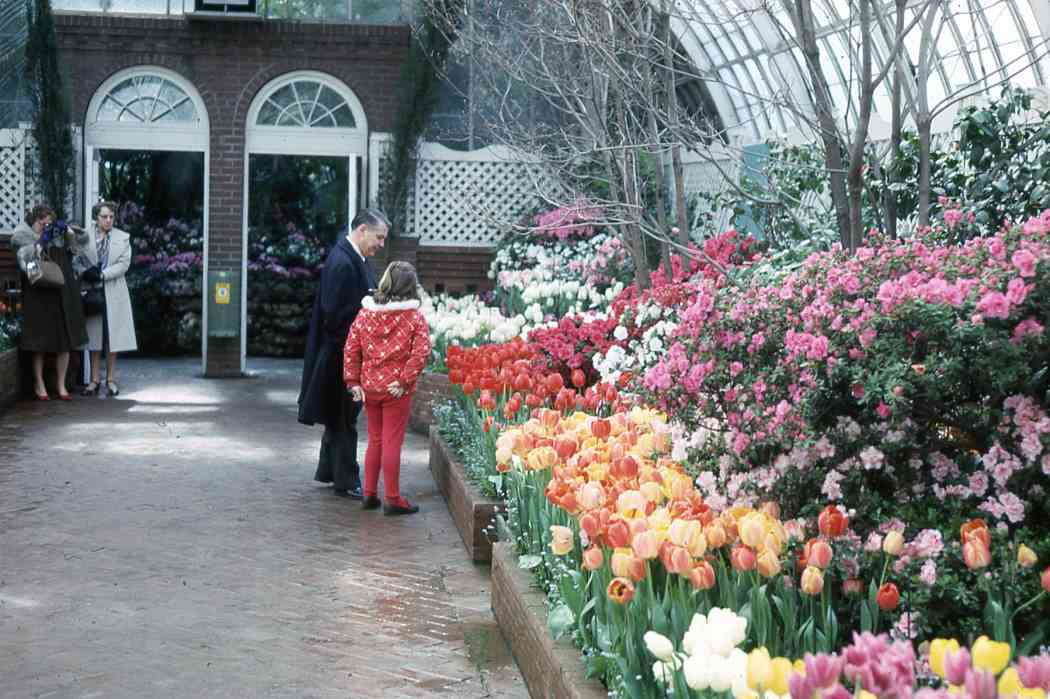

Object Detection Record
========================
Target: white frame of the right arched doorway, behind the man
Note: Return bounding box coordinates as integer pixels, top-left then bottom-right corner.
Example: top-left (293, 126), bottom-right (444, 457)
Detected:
top-left (240, 70), bottom-right (369, 374)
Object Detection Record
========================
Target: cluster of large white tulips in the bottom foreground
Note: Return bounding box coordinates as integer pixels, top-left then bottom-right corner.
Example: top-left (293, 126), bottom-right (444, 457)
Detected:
top-left (644, 607), bottom-right (748, 696)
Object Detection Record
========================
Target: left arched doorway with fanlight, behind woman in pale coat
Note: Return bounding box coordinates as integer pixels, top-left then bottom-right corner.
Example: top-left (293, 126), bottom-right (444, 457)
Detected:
top-left (84, 65), bottom-right (209, 366)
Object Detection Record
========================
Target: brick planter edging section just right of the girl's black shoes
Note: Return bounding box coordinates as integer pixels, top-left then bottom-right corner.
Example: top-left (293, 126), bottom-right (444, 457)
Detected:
top-left (431, 426), bottom-right (504, 563)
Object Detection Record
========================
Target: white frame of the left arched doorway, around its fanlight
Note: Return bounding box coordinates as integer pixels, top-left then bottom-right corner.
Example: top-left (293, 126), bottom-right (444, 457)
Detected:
top-left (83, 65), bottom-right (211, 374)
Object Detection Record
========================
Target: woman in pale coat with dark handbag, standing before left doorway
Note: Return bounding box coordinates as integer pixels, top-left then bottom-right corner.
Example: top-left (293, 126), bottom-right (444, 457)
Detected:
top-left (81, 202), bottom-right (139, 396)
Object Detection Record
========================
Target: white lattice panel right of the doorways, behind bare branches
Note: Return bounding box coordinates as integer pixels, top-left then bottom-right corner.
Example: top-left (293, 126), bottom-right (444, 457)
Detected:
top-left (411, 144), bottom-right (537, 247)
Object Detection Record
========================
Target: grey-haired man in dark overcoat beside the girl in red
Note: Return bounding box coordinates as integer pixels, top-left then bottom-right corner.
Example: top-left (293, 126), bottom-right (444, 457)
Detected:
top-left (299, 209), bottom-right (390, 500)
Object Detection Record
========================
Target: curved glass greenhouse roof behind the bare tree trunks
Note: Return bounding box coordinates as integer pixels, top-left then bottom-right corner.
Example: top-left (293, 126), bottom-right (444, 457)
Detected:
top-left (672, 0), bottom-right (1050, 143)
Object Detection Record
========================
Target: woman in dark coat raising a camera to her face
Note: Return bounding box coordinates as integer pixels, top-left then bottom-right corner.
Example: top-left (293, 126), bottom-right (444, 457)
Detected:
top-left (11, 205), bottom-right (87, 401)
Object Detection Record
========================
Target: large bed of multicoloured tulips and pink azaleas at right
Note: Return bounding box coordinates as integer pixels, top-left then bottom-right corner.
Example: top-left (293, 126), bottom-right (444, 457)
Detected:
top-left (428, 207), bottom-right (1050, 699)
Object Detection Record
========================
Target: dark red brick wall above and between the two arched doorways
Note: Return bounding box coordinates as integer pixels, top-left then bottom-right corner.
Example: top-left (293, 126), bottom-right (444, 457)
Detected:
top-left (55, 14), bottom-right (410, 376)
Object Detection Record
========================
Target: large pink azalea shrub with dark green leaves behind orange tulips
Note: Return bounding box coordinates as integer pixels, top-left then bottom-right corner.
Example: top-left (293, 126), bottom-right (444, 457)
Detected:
top-left (639, 211), bottom-right (1050, 638)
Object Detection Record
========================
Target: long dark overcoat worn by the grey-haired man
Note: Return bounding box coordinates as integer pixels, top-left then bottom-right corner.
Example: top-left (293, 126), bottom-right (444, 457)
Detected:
top-left (299, 236), bottom-right (376, 428)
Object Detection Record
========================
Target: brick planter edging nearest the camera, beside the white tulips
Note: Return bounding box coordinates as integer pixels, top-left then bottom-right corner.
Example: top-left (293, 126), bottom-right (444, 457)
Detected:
top-left (491, 542), bottom-right (609, 699)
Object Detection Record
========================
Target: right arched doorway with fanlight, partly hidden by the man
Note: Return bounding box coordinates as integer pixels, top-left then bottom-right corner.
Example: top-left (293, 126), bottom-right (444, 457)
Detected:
top-left (240, 70), bottom-right (369, 369)
